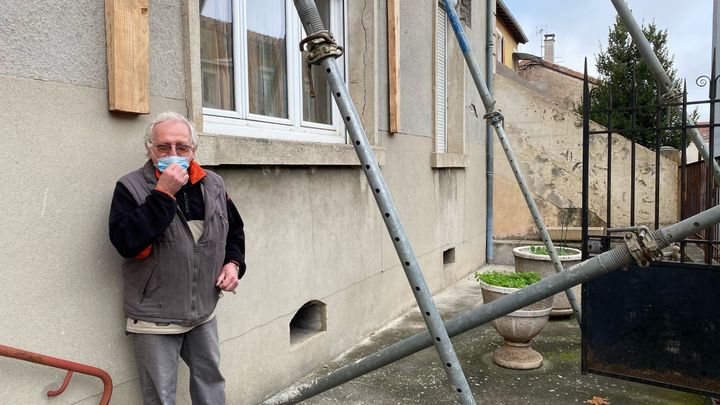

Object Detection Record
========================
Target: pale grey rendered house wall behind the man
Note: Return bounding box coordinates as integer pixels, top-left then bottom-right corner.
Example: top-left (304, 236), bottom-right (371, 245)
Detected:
top-left (0, 0), bottom-right (485, 404)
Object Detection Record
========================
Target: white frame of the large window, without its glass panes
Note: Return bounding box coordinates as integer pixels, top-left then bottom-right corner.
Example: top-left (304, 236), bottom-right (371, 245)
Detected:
top-left (202, 0), bottom-right (348, 143)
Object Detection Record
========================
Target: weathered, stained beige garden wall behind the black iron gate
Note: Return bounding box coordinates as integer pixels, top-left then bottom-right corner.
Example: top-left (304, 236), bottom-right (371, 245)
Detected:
top-left (494, 67), bottom-right (678, 239)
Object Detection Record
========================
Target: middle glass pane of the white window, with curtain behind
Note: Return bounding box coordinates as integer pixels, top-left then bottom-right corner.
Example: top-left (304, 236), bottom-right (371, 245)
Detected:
top-left (246, 0), bottom-right (288, 118)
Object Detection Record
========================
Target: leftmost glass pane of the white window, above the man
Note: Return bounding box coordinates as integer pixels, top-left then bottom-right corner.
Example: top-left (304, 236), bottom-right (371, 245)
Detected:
top-left (200, 0), bottom-right (235, 110)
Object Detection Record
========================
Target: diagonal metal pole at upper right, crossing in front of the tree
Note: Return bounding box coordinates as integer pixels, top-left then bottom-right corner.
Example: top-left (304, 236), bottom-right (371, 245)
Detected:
top-left (611, 0), bottom-right (720, 185)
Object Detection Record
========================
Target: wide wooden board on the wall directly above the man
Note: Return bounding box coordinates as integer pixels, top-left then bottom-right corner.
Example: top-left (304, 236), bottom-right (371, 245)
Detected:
top-left (105, 0), bottom-right (150, 114)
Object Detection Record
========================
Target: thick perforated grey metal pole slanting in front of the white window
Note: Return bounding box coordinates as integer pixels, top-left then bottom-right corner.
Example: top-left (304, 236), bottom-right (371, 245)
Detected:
top-left (294, 0), bottom-right (475, 404)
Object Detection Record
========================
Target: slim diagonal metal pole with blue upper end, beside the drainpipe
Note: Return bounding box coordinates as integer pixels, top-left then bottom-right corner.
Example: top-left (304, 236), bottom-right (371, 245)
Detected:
top-left (443, 0), bottom-right (581, 324)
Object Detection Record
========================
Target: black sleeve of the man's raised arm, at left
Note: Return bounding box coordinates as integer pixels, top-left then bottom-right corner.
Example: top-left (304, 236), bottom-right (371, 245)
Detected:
top-left (110, 182), bottom-right (177, 258)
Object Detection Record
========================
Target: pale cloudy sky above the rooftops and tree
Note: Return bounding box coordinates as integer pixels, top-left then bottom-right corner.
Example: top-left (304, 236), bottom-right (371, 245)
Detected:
top-left (504, 0), bottom-right (713, 117)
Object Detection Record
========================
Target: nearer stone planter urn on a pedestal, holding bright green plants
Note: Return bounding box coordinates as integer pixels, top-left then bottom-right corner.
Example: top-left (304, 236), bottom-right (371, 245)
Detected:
top-left (478, 280), bottom-right (552, 370)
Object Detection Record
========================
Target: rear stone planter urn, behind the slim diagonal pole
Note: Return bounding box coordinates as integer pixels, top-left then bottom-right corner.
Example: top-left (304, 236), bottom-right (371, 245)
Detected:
top-left (513, 246), bottom-right (582, 317)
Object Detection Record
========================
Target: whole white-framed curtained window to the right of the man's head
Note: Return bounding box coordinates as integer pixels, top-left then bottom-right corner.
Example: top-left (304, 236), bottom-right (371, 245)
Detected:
top-left (200, 0), bottom-right (345, 143)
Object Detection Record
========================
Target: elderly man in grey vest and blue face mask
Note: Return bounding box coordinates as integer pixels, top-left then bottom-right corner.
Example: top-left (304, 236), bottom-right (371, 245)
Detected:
top-left (110, 112), bottom-right (245, 404)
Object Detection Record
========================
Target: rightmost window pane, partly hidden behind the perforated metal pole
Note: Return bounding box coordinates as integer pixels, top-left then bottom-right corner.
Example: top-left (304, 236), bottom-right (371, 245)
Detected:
top-left (302, 0), bottom-right (332, 124)
